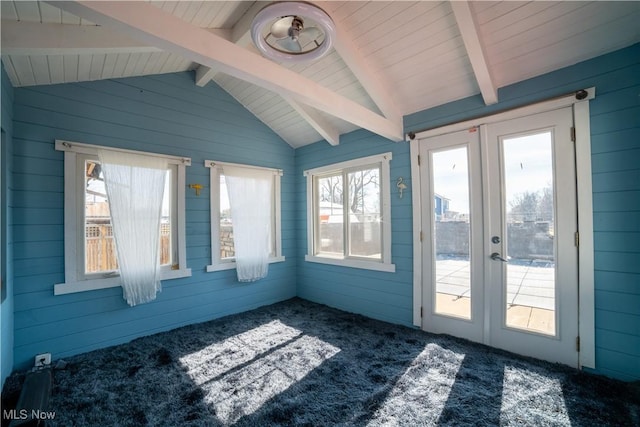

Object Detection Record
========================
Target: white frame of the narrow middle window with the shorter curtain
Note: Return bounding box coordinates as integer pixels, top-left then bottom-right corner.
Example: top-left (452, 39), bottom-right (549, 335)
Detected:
top-left (204, 160), bottom-right (285, 273)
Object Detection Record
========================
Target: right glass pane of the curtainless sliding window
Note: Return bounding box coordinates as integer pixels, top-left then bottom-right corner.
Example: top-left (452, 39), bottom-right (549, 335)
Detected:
top-left (345, 168), bottom-right (382, 259)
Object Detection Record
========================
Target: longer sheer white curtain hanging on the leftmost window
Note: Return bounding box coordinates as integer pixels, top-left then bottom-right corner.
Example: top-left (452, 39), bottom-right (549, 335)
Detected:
top-left (98, 150), bottom-right (168, 306)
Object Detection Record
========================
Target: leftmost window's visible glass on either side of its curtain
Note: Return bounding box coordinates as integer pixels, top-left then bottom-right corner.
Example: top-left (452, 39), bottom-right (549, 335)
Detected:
top-left (84, 160), bottom-right (173, 274)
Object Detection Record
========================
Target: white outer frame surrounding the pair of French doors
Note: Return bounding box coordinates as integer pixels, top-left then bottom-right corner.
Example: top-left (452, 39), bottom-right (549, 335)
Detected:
top-left (408, 87), bottom-right (595, 368)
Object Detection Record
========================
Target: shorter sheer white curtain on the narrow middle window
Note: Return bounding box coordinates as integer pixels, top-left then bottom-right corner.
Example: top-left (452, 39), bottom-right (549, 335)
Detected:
top-left (223, 165), bottom-right (273, 282)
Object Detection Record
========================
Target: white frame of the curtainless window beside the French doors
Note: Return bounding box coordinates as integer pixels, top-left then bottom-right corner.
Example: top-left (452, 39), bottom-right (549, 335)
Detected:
top-left (304, 152), bottom-right (396, 272)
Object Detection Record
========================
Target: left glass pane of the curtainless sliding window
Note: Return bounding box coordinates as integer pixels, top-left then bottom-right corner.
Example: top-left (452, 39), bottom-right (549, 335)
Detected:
top-left (316, 175), bottom-right (344, 256)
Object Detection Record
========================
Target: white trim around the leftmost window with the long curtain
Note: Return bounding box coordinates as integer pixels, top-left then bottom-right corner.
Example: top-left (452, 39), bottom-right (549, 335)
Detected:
top-left (53, 140), bottom-right (191, 295)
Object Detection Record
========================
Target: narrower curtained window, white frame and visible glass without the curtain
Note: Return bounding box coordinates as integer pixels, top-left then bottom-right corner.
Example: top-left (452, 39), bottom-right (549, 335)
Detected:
top-left (205, 160), bottom-right (285, 272)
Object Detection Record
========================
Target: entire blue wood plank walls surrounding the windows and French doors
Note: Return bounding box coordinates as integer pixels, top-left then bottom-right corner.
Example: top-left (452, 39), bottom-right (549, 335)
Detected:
top-left (1, 45), bottom-right (640, 380)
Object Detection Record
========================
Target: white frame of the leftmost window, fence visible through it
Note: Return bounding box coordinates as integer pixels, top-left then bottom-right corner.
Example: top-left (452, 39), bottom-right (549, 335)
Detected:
top-left (54, 140), bottom-right (191, 295)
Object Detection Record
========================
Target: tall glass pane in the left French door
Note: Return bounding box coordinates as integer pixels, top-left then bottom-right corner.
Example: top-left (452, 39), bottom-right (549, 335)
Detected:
top-left (431, 147), bottom-right (471, 319)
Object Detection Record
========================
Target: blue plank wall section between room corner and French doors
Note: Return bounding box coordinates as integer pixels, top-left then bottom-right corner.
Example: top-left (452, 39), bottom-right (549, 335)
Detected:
top-left (296, 130), bottom-right (413, 325)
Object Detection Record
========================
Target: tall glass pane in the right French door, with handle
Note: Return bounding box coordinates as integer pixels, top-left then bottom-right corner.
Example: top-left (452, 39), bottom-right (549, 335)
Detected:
top-left (502, 131), bottom-right (556, 335)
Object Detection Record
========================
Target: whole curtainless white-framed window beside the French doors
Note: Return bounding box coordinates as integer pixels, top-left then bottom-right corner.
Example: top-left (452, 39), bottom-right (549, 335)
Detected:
top-left (305, 153), bottom-right (395, 271)
